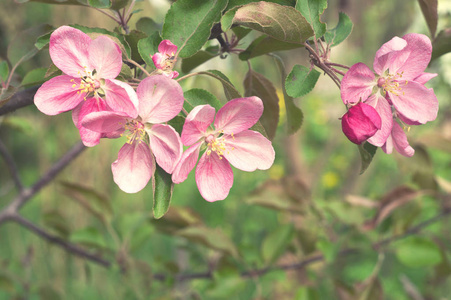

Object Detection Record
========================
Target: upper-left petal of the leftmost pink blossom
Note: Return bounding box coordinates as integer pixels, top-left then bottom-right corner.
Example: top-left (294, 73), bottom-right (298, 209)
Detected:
top-left (49, 26), bottom-right (93, 78)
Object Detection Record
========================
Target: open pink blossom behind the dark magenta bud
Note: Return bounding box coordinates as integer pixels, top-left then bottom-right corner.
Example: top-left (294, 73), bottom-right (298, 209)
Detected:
top-left (341, 33), bottom-right (438, 154)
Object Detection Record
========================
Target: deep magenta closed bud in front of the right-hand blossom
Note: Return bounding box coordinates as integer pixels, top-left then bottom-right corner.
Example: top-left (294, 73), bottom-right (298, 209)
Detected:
top-left (341, 102), bottom-right (382, 145)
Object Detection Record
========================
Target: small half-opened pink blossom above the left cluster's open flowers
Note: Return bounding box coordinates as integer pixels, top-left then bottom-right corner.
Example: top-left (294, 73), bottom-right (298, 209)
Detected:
top-left (152, 40), bottom-right (179, 78)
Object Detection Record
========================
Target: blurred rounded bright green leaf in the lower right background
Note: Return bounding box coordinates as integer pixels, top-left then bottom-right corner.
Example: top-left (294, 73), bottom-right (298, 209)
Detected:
top-left (395, 237), bottom-right (442, 268)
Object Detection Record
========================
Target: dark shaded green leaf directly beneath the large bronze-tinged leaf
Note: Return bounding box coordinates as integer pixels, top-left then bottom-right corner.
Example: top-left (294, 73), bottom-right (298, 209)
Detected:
top-left (239, 35), bottom-right (303, 60)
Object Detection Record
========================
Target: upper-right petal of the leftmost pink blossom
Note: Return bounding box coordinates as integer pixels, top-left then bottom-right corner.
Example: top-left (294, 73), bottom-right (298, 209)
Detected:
top-left (89, 35), bottom-right (122, 79)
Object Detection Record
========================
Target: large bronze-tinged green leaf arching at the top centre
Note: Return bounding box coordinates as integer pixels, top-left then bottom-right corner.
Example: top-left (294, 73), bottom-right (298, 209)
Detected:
top-left (221, 1), bottom-right (313, 44)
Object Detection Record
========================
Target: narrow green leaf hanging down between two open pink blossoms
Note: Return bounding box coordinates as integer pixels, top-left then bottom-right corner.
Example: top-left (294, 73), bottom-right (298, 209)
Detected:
top-left (152, 165), bottom-right (174, 219)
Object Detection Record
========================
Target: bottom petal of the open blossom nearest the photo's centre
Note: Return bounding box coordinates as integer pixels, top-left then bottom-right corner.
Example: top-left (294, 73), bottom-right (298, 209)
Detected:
top-left (196, 152), bottom-right (233, 202)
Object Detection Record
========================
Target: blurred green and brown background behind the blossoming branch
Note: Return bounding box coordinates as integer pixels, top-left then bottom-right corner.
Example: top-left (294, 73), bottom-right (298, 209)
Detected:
top-left (0, 0), bottom-right (451, 300)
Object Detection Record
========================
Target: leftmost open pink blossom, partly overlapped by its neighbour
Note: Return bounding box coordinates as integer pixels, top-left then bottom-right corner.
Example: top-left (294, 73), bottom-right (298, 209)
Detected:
top-left (34, 26), bottom-right (138, 146)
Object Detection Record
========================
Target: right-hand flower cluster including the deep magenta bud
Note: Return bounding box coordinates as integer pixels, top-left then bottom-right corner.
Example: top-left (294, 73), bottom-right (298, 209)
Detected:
top-left (341, 33), bottom-right (438, 156)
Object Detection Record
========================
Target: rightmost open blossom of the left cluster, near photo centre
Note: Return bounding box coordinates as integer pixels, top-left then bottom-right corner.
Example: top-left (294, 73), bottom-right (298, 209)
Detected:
top-left (172, 97), bottom-right (275, 201)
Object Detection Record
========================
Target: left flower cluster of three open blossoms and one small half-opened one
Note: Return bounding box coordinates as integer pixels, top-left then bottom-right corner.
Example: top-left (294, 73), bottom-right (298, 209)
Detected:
top-left (34, 26), bottom-right (274, 201)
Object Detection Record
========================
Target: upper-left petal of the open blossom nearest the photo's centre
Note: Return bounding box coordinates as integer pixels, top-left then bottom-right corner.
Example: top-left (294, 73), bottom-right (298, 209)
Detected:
top-left (182, 104), bottom-right (215, 146)
